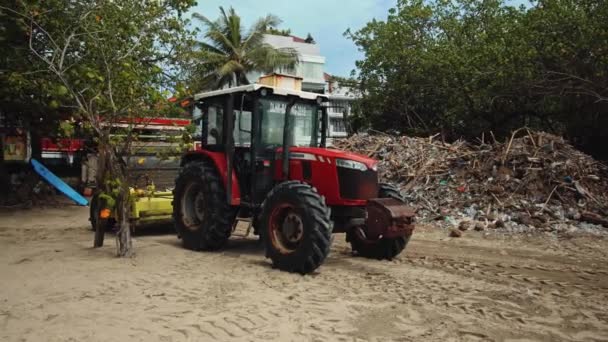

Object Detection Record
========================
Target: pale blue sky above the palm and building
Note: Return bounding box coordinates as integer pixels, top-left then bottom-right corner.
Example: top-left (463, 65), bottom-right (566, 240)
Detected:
top-left (191, 0), bottom-right (527, 76)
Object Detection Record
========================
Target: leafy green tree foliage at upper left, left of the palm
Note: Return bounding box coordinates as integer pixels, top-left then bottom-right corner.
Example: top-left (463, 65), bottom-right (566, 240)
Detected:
top-left (0, 0), bottom-right (194, 135)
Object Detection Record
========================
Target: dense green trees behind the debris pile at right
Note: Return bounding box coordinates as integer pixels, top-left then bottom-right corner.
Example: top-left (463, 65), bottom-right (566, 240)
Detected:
top-left (345, 0), bottom-right (608, 158)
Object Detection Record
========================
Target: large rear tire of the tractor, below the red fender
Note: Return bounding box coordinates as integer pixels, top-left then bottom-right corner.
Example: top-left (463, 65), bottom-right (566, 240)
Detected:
top-left (173, 161), bottom-right (236, 251)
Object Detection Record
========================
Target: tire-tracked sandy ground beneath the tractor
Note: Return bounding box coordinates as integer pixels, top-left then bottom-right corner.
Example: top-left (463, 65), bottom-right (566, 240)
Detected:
top-left (0, 205), bottom-right (608, 341)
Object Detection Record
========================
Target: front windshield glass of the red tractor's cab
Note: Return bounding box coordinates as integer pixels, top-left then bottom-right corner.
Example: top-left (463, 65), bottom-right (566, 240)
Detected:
top-left (260, 99), bottom-right (318, 147)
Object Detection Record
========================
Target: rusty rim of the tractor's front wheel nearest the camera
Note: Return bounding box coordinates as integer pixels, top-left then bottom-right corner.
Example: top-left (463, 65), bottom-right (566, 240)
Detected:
top-left (268, 204), bottom-right (304, 254)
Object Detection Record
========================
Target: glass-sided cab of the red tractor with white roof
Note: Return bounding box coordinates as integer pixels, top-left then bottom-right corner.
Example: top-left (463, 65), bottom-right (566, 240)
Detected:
top-left (187, 84), bottom-right (334, 208)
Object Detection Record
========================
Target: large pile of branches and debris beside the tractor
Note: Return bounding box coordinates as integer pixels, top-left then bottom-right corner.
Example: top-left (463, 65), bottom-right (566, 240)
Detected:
top-left (334, 129), bottom-right (608, 231)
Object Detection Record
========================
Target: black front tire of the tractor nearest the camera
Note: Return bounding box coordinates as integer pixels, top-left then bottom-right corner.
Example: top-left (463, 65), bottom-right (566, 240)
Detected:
top-left (259, 181), bottom-right (333, 274)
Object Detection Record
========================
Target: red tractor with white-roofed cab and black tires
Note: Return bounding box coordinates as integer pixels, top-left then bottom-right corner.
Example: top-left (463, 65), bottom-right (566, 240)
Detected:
top-left (173, 84), bottom-right (414, 274)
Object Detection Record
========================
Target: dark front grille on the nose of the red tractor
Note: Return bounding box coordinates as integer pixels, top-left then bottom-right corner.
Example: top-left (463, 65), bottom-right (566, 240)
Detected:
top-left (338, 167), bottom-right (378, 200)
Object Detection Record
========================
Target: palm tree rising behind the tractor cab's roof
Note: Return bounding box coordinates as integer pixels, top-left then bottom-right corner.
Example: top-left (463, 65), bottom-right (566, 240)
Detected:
top-left (193, 7), bottom-right (298, 89)
